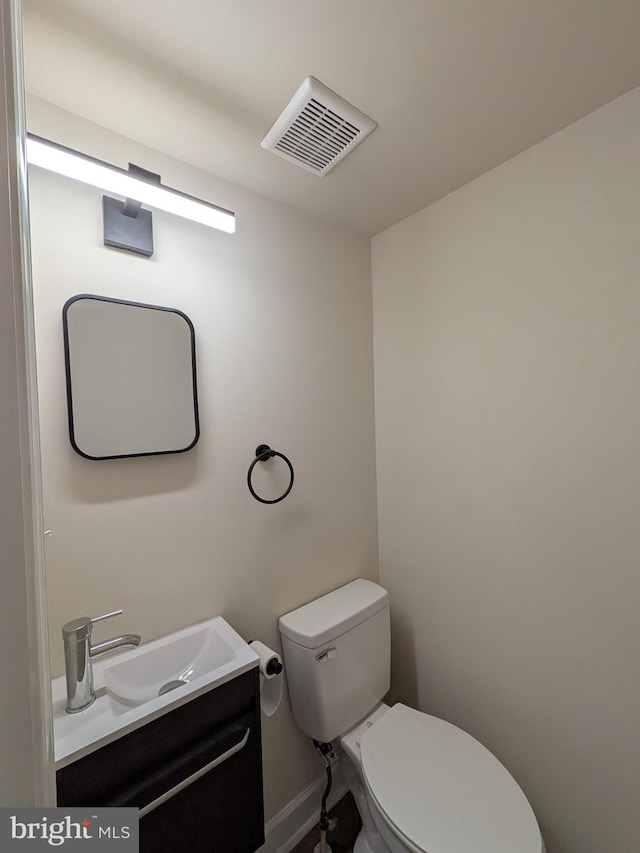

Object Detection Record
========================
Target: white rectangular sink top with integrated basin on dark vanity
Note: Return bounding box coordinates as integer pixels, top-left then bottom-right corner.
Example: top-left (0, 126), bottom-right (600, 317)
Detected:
top-left (53, 616), bottom-right (258, 768)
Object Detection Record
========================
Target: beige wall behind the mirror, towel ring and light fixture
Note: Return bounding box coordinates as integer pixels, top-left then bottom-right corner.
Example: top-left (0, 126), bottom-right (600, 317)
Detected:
top-left (29, 99), bottom-right (377, 817)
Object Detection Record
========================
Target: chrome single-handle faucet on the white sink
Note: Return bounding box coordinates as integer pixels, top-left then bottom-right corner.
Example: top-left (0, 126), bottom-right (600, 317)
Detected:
top-left (62, 610), bottom-right (140, 714)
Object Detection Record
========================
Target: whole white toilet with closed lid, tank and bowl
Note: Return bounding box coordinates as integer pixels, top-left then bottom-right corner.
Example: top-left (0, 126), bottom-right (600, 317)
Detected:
top-left (280, 580), bottom-right (544, 853)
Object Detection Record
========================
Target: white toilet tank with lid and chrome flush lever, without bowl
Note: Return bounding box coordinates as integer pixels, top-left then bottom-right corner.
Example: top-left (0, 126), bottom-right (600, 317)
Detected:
top-left (279, 579), bottom-right (391, 743)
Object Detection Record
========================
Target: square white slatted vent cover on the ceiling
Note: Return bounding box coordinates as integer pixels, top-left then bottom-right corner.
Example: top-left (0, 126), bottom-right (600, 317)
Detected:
top-left (261, 77), bottom-right (376, 175)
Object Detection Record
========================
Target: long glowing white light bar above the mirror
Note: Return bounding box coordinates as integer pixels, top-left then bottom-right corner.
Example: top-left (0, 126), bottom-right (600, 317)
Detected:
top-left (27, 133), bottom-right (236, 234)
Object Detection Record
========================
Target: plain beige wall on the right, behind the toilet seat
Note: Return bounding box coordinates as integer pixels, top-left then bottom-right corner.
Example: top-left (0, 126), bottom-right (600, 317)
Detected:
top-left (372, 90), bottom-right (640, 853)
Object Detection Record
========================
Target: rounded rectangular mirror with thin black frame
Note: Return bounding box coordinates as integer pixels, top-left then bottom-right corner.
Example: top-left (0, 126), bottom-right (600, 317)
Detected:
top-left (62, 294), bottom-right (200, 459)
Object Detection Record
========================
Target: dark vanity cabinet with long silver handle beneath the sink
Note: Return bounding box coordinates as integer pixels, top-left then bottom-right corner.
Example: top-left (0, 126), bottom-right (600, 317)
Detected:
top-left (57, 668), bottom-right (264, 853)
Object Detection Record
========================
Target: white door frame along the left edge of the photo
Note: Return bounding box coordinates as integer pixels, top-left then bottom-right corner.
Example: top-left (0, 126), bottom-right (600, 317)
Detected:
top-left (0, 0), bottom-right (55, 806)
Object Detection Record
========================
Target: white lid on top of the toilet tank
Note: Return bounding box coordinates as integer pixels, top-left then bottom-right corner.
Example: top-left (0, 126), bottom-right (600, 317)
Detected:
top-left (279, 578), bottom-right (389, 649)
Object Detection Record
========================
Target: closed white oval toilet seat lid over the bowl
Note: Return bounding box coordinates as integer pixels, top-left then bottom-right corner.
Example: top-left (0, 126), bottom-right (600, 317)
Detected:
top-left (360, 704), bottom-right (543, 853)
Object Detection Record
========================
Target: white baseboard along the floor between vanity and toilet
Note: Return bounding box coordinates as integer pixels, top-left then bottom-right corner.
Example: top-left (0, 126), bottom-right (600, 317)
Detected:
top-left (256, 765), bottom-right (347, 853)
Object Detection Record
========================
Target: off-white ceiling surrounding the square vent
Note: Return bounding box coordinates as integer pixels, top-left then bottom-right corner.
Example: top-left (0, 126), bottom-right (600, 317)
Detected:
top-left (24, 0), bottom-right (640, 235)
